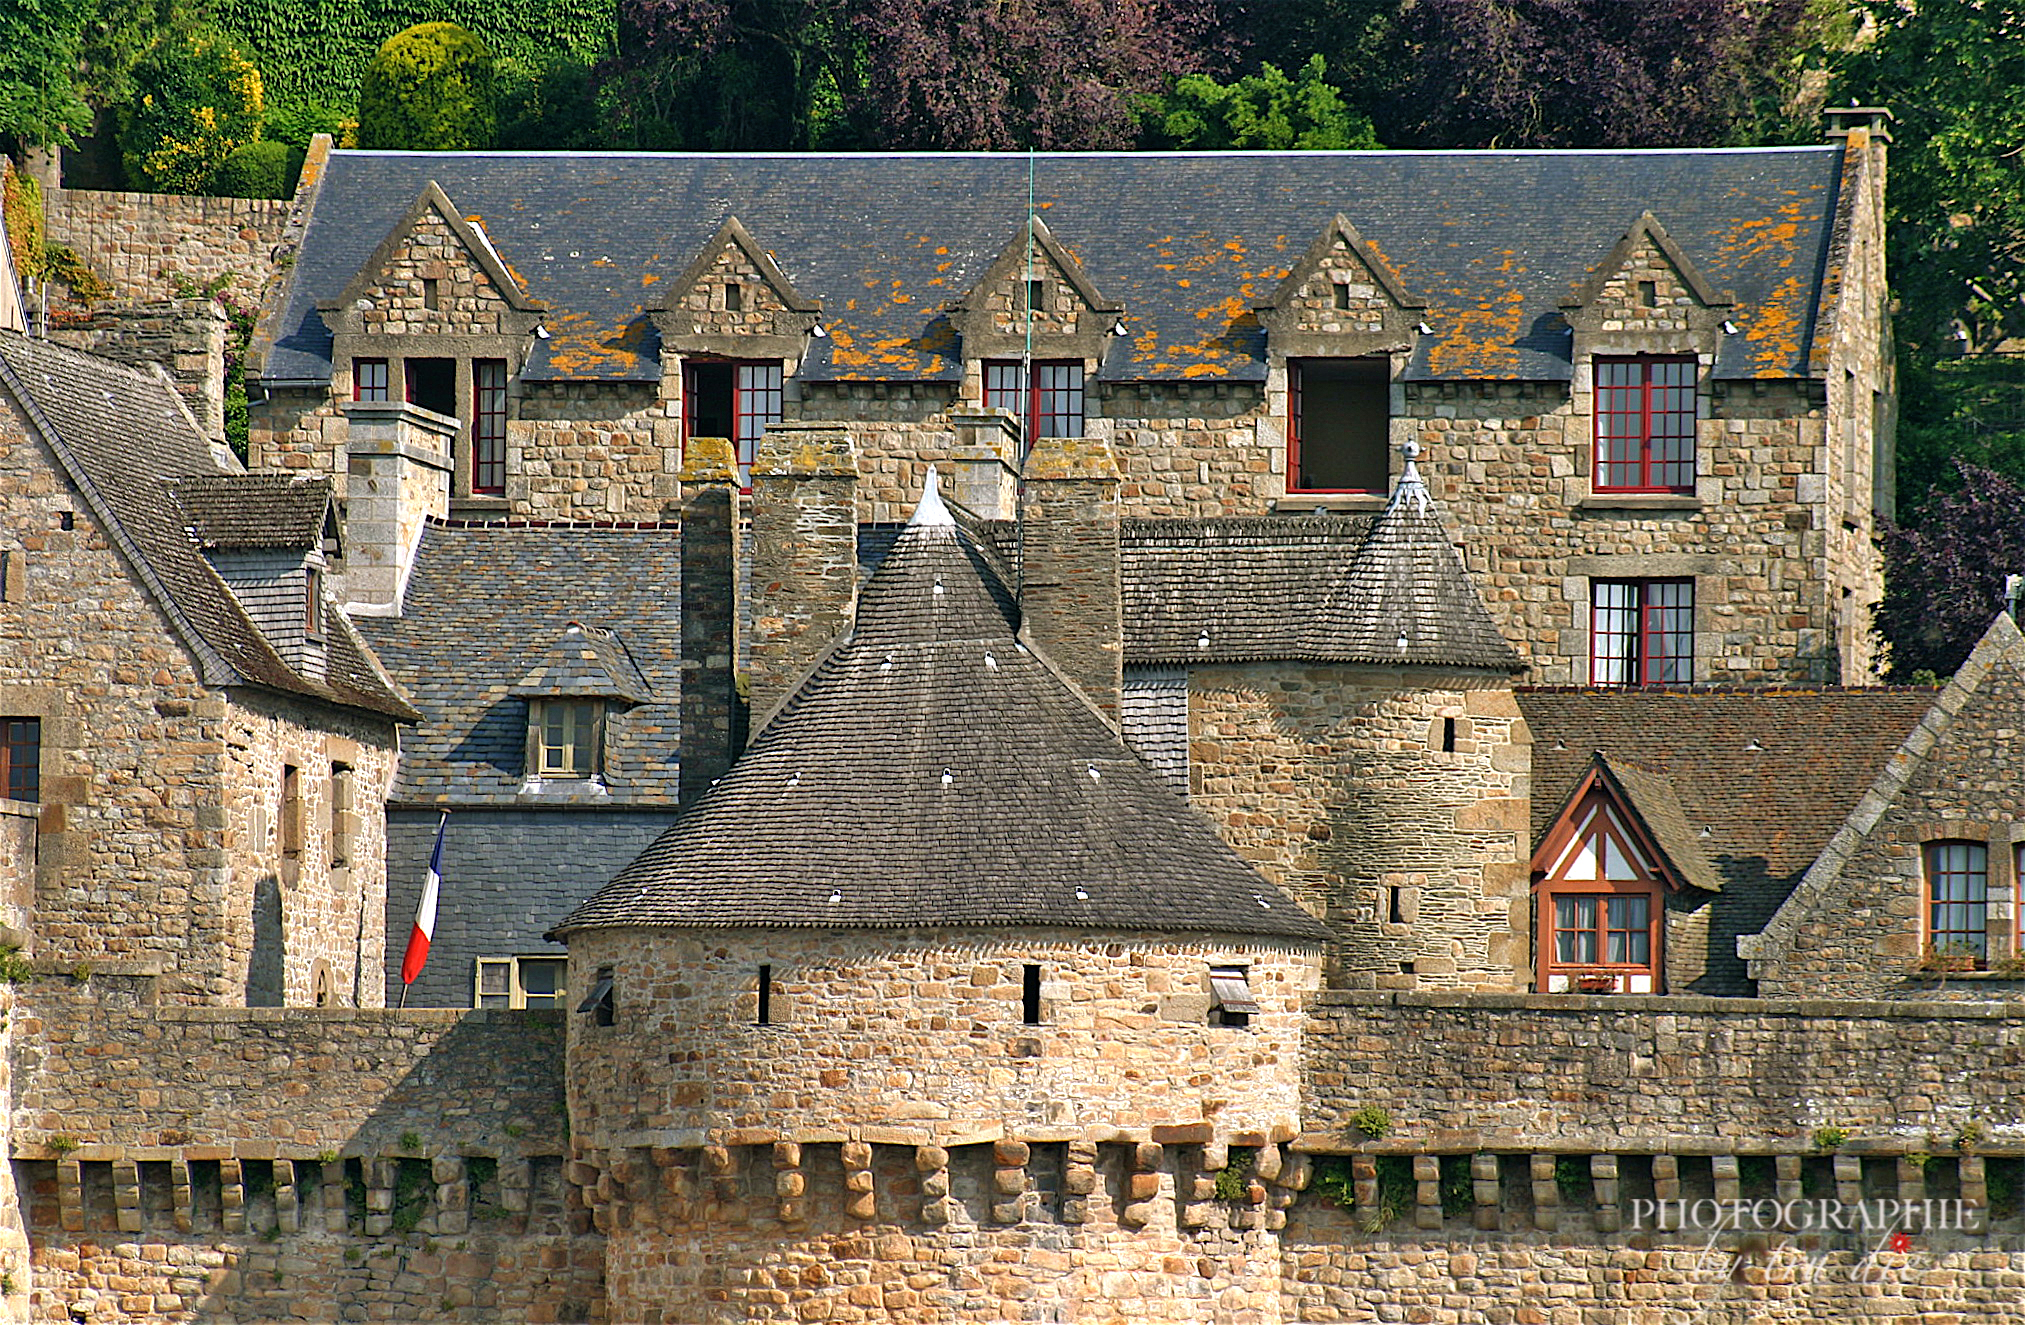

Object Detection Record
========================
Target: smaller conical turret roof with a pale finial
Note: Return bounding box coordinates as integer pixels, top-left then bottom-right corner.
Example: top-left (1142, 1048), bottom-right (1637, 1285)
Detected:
top-left (1304, 442), bottom-right (1525, 673)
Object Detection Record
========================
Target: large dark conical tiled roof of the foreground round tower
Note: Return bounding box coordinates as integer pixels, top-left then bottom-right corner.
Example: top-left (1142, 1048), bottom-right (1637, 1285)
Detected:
top-left (557, 492), bottom-right (1324, 940)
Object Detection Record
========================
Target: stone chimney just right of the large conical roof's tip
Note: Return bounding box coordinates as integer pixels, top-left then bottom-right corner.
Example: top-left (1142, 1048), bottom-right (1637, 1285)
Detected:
top-left (1021, 438), bottom-right (1124, 723)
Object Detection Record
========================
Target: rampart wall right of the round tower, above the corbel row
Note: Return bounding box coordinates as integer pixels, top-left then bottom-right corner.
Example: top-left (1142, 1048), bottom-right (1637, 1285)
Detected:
top-left (1302, 991), bottom-right (2025, 1153)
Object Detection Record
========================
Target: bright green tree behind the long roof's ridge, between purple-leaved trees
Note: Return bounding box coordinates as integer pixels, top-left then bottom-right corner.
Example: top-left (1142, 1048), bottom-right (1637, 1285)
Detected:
top-left (1142, 55), bottom-right (1379, 152)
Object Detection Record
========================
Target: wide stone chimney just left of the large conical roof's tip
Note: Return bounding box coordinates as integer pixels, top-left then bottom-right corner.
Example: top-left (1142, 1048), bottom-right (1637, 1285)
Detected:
top-left (747, 423), bottom-right (859, 723)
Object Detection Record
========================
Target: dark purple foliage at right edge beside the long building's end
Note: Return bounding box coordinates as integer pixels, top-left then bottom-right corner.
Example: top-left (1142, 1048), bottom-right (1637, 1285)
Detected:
top-left (1875, 462), bottom-right (2025, 681)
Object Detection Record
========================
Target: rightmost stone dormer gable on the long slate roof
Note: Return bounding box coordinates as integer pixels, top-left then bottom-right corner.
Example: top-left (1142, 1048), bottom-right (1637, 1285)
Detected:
top-left (1561, 213), bottom-right (1735, 363)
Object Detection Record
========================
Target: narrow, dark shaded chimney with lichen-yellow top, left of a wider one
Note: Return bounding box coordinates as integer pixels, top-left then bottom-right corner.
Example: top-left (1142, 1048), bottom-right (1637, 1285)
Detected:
top-left (680, 438), bottom-right (741, 804)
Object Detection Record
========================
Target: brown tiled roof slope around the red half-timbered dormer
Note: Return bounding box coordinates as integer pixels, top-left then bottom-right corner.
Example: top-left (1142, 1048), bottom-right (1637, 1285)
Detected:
top-left (1519, 687), bottom-right (1934, 975)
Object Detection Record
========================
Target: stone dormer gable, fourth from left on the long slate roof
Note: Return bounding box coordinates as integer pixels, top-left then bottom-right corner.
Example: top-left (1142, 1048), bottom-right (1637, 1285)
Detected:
top-left (1258, 213), bottom-right (1428, 357)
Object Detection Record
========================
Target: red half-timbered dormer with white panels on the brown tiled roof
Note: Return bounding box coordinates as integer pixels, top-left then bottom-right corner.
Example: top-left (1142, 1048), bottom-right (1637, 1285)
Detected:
top-left (1533, 754), bottom-right (1723, 993)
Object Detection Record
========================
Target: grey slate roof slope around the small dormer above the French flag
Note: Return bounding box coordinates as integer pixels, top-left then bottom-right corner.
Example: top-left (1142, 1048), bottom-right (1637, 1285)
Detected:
top-left (358, 521), bottom-right (682, 804)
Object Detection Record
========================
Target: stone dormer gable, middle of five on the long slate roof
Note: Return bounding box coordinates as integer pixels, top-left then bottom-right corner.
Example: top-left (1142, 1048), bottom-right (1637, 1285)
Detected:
top-left (950, 217), bottom-right (1124, 361)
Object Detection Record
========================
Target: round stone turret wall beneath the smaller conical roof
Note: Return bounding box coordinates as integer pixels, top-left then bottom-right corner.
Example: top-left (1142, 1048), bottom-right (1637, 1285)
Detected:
top-left (1189, 663), bottom-right (1531, 989)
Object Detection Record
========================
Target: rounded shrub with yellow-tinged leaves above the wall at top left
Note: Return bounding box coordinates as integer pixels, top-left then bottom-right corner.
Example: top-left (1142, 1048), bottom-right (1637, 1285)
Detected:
top-left (119, 30), bottom-right (261, 192)
